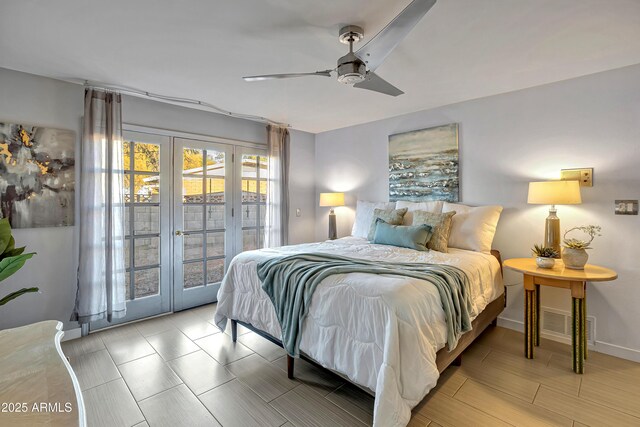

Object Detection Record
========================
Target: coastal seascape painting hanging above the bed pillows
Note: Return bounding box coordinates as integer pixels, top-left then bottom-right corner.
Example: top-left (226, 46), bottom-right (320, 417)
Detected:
top-left (389, 123), bottom-right (460, 202)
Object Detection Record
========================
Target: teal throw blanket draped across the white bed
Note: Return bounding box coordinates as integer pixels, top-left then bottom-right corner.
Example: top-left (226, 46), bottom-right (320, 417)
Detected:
top-left (258, 253), bottom-right (471, 357)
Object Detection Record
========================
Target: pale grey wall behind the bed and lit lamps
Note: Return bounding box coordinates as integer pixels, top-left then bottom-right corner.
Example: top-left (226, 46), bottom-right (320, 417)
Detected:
top-left (316, 66), bottom-right (640, 360)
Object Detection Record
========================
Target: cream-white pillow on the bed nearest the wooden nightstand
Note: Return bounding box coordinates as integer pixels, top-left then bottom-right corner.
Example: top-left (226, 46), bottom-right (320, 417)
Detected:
top-left (442, 202), bottom-right (502, 253)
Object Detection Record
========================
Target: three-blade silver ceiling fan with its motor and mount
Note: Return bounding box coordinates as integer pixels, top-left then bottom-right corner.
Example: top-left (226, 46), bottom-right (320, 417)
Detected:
top-left (243, 0), bottom-right (436, 96)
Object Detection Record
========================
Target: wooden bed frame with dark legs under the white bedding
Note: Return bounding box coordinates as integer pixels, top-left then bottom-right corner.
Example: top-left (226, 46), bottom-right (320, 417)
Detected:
top-left (231, 249), bottom-right (507, 386)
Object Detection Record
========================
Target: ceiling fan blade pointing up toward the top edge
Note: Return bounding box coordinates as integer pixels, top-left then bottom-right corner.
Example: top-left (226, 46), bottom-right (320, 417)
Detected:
top-left (355, 0), bottom-right (436, 71)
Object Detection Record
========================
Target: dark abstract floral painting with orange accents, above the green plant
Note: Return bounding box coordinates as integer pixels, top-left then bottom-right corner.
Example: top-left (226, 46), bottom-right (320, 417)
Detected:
top-left (0, 122), bottom-right (76, 228)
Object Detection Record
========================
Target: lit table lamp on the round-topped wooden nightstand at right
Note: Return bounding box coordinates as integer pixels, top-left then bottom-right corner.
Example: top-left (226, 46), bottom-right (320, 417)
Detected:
top-left (527, 181), bottom-right (582, 256)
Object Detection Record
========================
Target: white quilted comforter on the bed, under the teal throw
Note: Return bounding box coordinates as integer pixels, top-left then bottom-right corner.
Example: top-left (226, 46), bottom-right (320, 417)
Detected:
top-left (215, 237), bottom-right (503, 427)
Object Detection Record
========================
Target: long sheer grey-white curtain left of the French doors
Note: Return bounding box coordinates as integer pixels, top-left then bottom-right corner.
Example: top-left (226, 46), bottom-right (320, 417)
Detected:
top-left (71, 88), bottom-right (126, 324)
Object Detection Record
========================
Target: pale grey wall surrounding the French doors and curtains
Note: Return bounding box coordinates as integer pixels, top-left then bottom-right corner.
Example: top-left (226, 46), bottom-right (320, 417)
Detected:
top-left (0, 68), bottom-right (315, 329)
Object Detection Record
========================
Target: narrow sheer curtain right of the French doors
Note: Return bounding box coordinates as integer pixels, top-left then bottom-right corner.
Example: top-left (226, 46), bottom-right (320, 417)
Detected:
top-left (264, 125), bottom-right (289, 248)
